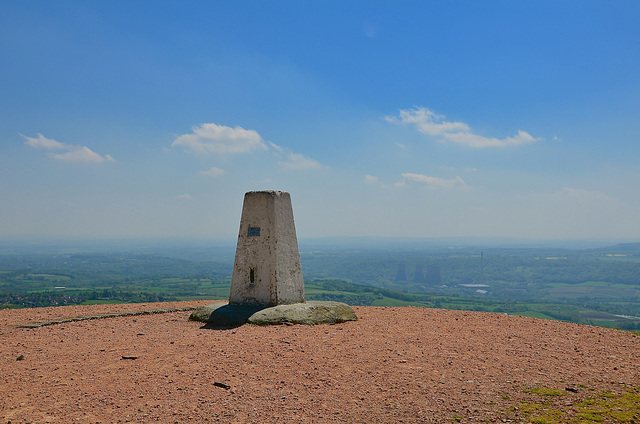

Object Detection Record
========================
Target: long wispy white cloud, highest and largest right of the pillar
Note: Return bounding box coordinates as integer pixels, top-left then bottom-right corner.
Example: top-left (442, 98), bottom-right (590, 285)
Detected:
top-left (384, 107), bottom-right (542, 148)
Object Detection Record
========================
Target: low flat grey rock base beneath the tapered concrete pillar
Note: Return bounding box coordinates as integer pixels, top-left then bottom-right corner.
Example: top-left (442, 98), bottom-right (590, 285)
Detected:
top-left (189, 302), bottom-right (358, 327)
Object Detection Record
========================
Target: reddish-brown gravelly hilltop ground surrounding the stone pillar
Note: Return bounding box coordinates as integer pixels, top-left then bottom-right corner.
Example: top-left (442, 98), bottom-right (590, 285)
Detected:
top-left (0, 302), bottom-right (640, 424)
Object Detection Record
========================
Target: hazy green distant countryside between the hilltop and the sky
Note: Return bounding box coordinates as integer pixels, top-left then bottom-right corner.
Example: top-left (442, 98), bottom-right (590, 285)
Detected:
top-left (0, 240), bottom-right (640, 330)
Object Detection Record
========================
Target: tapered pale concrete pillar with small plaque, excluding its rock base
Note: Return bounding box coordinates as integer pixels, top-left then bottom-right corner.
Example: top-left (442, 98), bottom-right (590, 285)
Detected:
top-left (229, 190), bottom-right (305, 306)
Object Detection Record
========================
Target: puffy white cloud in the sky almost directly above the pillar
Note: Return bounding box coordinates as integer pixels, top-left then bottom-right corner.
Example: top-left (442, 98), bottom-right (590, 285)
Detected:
top-left (172, 124), bottom-right (268, 155)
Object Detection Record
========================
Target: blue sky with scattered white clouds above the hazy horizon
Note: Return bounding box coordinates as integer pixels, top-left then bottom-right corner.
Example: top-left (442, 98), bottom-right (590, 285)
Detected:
top-left (0, 0), bottom-right (640, 240)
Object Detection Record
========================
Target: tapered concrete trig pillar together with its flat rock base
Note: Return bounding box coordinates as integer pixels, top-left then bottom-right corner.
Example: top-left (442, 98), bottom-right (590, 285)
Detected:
top-left (189, 190), bottom-right (358, 328)
